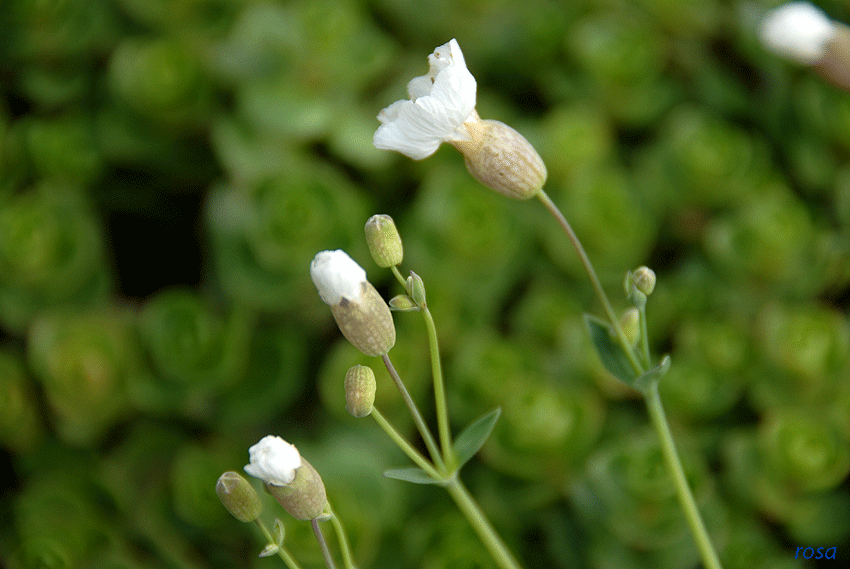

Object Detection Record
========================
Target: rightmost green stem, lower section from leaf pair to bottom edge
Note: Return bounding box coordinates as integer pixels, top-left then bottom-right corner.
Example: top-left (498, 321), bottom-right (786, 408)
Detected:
top-left (644, 381), bottom-right (721, 569)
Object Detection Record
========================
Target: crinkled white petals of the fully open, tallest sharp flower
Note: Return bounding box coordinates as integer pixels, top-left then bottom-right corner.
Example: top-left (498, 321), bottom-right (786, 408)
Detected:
top-left (373, 39), bottom-right (478, 160)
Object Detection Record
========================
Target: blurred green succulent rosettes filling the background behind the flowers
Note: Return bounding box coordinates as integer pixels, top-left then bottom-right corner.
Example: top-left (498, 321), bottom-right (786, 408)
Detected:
top-left (0, 0), bottom-right (850, 569)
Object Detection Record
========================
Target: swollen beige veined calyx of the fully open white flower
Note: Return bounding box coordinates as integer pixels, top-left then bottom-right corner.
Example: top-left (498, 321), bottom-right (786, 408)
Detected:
top-left (450, 111), bottom-right (546, 200)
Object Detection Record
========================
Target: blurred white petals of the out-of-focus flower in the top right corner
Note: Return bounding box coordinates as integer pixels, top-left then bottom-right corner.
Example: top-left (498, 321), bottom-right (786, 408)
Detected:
top-left (761, 2), bottom-right (836, 65)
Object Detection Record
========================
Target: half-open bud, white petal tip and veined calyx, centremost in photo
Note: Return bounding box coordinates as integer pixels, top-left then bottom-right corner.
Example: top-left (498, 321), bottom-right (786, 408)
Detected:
top-left (310, 250), bottom-right (395, 356)
